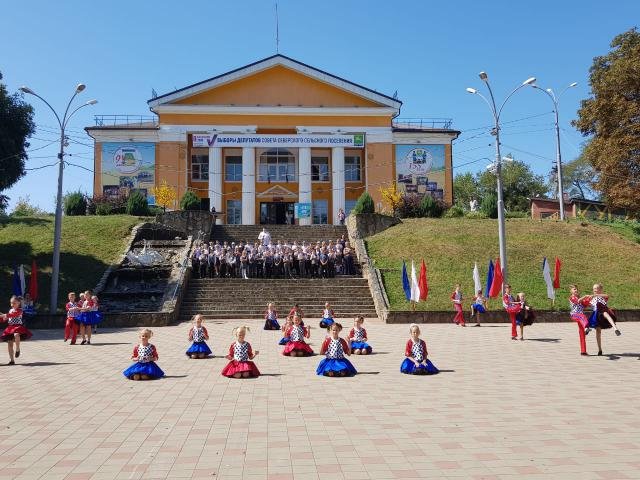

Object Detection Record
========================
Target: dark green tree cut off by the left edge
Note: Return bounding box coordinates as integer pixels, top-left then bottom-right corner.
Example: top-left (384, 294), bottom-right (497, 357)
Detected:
top-left (0, 73), bottom-right (36, 209)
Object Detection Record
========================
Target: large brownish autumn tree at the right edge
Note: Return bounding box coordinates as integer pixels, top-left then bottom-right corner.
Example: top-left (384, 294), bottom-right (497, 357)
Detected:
top-left (574, 28), bottom-right (640, 212)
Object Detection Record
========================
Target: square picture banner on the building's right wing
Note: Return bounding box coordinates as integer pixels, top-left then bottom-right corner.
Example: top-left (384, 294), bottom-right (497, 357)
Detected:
top-left (396, 145), bottom-right (445, 200)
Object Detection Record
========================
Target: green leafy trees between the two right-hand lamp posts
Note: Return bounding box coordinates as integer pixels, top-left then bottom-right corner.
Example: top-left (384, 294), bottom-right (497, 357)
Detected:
top-left (477, 160), bottom-right (548, 212)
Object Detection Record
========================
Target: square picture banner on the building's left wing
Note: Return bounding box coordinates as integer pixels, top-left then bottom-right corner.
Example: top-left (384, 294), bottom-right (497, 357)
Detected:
top-left (100, 142), bottom-right (156, 204)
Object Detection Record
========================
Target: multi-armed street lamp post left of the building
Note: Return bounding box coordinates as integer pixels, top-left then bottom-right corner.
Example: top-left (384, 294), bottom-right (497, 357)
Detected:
top-left (20, 83), bottom-right (98, 314)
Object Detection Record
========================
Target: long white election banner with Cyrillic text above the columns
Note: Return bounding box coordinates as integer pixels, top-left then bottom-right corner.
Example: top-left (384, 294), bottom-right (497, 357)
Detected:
top-left (192, 133), bottom-right (364, 148)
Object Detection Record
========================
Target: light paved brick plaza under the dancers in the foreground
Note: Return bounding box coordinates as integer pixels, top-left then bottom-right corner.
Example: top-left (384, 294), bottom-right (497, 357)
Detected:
top-left (0, 320), bottom-right (640, 480)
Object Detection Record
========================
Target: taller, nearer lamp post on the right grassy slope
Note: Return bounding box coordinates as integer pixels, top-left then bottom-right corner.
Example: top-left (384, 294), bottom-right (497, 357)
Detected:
top-left (467, 72), bottom-right (536, 283)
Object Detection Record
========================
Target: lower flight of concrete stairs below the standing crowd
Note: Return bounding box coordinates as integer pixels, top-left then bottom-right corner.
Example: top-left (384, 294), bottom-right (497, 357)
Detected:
top-left (180, 277), bottom-right (376, 321)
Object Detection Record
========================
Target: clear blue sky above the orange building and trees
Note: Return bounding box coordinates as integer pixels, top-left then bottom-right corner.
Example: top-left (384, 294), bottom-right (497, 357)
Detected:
top-left (0, 0), bottom-right (640, 211)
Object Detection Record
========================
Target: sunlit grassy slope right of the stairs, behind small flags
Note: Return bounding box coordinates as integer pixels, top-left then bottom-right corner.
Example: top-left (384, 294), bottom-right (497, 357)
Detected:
top-left (366, 218), bottom-right (640, 310)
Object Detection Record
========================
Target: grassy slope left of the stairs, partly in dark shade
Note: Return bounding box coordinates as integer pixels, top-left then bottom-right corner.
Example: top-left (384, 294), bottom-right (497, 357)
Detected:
top-left (0, 215), bottom-right (145, 312)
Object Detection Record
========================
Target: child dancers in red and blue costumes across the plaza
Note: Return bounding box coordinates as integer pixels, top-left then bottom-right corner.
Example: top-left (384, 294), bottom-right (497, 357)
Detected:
top-left (0, 283), bottom-right (622, 368)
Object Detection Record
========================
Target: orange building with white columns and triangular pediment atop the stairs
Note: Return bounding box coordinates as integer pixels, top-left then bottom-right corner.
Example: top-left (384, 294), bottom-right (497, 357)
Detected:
top-left (85, 55), bottom-right (460, 225)
